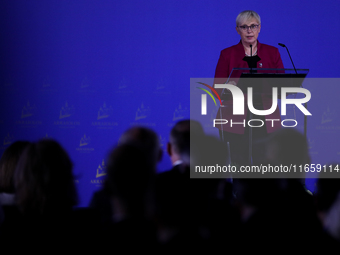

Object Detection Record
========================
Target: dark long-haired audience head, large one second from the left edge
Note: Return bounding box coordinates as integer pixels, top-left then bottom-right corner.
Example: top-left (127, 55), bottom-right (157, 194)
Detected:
top-left (14, 140), bottom-right (77, 216)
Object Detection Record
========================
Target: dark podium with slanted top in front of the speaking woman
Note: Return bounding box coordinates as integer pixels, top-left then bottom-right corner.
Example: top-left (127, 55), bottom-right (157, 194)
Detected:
top-left (220, 68), bottom-right (309, 164)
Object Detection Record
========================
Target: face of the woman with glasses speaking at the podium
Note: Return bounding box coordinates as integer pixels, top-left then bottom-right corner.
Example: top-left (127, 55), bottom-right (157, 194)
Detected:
top-left (236, 18), bottom-right (261, 45)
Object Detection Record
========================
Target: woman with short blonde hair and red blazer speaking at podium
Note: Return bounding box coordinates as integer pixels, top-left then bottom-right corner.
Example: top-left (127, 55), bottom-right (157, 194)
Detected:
top-left (214, 11), bottom-right (283, 165)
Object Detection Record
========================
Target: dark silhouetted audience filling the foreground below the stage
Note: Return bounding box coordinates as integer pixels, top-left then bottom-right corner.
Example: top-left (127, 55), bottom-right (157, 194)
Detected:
top-left (0, 123), bottom-right (340, 253)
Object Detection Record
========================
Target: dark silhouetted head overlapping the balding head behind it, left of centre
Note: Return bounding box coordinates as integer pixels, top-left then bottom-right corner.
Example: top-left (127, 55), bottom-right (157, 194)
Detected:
top-left (105, 143), bottom-right (155, 220)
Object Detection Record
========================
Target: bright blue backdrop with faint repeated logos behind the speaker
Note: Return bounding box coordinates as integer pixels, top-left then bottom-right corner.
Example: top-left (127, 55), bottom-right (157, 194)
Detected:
top-left (0, 0), bottom-right (340, 206)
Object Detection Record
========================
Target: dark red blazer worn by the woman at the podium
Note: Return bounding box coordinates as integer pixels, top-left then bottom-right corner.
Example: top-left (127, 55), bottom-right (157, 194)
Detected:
top-left (214, 41), bottom-right (284, 134)
